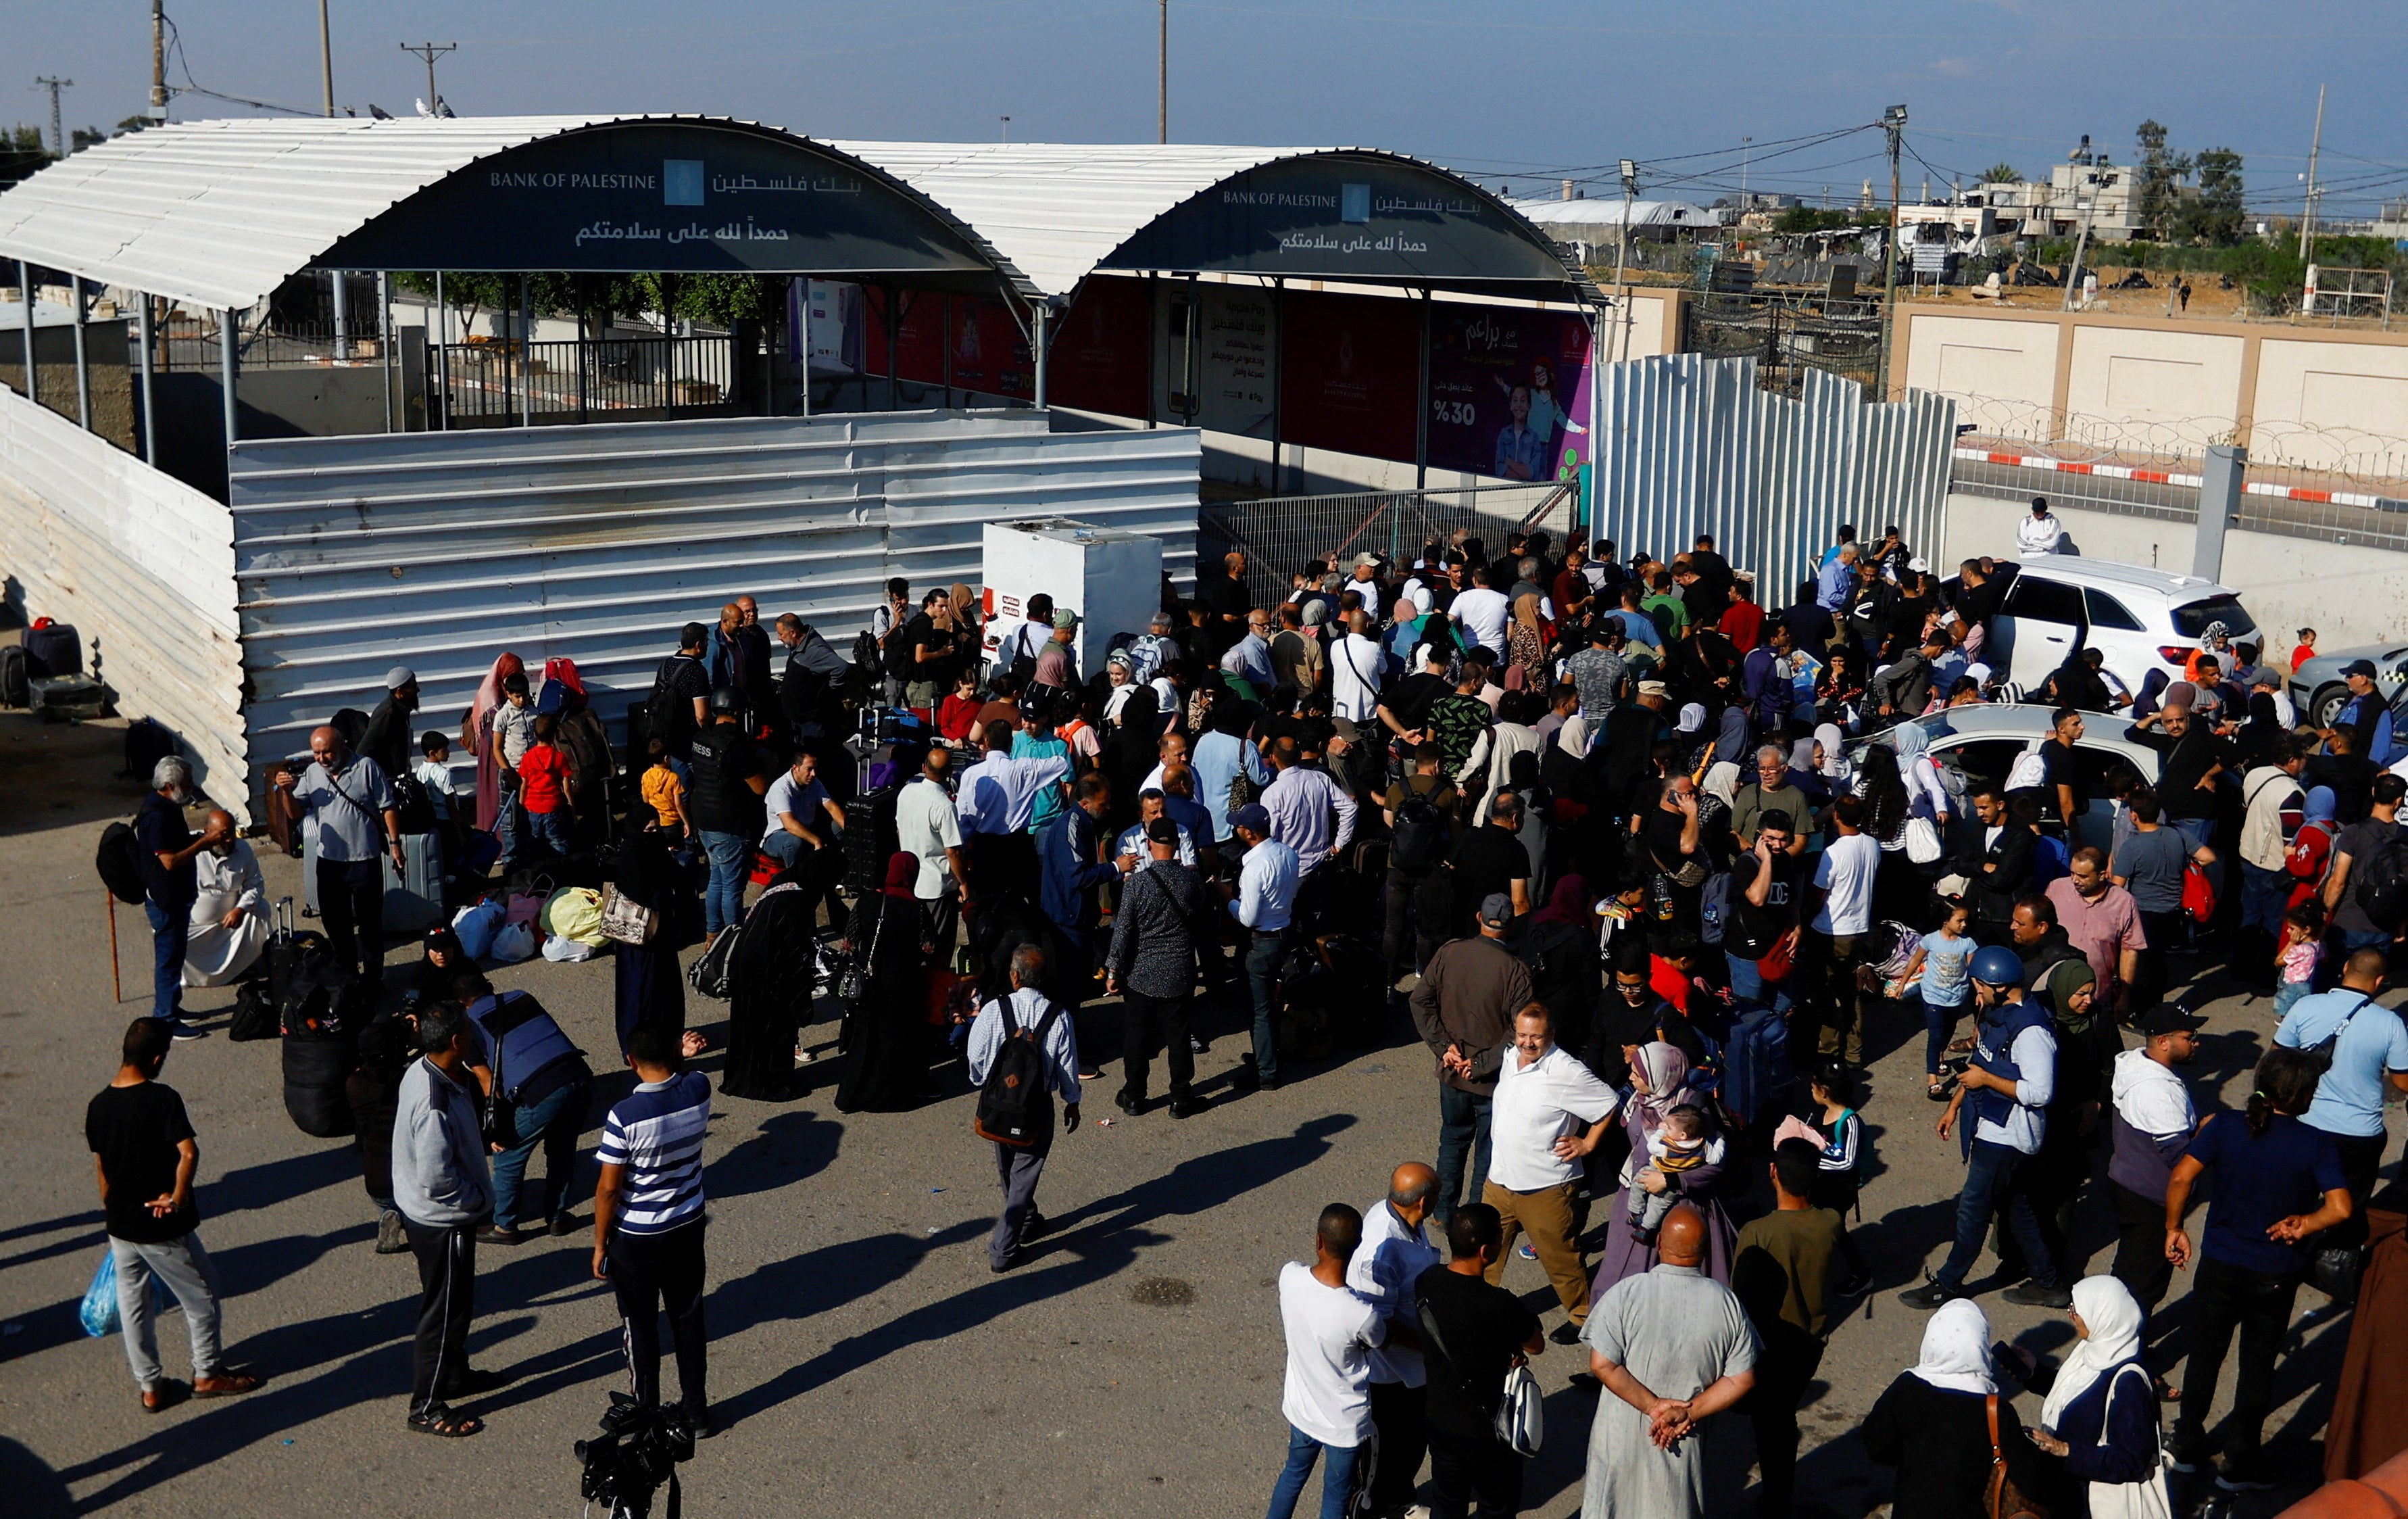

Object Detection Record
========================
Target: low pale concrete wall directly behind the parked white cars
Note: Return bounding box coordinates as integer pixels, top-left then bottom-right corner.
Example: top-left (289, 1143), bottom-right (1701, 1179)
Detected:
top-left (1941, 493), bottom-right (2408, 655)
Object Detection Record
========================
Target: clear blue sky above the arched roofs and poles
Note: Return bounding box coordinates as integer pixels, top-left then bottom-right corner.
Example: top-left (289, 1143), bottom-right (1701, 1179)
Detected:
top-left (18, 0), bottom-right (2408, 214)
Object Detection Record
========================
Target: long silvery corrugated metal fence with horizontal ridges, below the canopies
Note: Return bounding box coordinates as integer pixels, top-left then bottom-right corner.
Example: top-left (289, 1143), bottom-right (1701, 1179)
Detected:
top-left (231, 412), bottom-right (1199, 779)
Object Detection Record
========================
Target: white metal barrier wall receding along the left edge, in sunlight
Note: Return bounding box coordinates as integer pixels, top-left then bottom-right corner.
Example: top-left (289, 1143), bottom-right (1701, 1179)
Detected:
top-left (0, 387), bottom-right (251, 823)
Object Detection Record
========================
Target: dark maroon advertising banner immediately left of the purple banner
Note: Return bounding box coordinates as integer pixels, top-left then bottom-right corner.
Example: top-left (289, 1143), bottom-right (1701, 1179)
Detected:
top-left (1279, 291), bottom-right (1421, 464)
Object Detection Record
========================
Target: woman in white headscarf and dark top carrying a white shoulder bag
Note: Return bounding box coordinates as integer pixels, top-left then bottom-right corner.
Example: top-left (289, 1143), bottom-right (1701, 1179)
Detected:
top-left (2032, 1276), bottom-right (2172, 1519)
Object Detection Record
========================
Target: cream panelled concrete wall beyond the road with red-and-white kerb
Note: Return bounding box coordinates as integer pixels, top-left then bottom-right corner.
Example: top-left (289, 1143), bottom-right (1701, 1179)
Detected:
top-left (1890, 304), bottom-right (2408, 479)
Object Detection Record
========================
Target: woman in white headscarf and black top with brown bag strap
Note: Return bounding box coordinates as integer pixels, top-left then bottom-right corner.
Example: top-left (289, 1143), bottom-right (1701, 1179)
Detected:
top-left (1859, 1297), bottom-right (2044, 1519)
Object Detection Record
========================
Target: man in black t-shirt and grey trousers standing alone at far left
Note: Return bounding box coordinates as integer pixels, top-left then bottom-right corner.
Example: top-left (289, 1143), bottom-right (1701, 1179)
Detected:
top-left (84, 1018), bottom-right (260, 1413)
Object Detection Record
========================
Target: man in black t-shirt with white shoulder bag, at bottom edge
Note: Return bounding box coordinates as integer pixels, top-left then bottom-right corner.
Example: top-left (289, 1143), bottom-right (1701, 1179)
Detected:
top-left (1413, 1204), bottom-right (1546, 1514)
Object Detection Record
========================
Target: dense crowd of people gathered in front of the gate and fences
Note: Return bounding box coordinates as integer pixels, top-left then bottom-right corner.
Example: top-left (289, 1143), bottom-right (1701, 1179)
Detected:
top-left (94, 517), bottom-right (2408, 1519)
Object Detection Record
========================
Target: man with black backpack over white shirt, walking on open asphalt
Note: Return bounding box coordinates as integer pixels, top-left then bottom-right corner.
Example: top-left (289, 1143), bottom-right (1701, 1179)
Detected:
top-left (968, 944), bottom-right (1079, 1271)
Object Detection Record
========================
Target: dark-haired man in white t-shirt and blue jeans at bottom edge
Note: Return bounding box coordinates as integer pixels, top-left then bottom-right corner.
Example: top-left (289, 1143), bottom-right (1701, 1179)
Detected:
top-left (1269, 1204), bottom-right (1387, 1519)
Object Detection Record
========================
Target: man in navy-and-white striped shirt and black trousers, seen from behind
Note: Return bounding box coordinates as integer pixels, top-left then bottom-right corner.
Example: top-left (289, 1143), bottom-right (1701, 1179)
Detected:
top-left (595, 1023), bottom-right (710, 1439)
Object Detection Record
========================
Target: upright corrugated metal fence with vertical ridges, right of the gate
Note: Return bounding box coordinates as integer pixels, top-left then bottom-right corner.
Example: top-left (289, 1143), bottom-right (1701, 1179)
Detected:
top-left (1596, 354), bottom-right (1955, 604)
